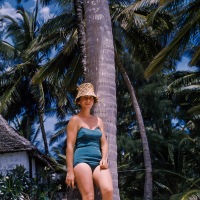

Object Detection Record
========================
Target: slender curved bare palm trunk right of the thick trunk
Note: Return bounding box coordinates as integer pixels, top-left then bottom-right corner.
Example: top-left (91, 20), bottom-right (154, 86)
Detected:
top-left (116, 56), bottom-right (152, 200)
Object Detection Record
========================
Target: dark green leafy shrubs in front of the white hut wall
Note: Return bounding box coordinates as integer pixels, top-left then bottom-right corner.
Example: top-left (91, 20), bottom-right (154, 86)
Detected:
top-left (0, 166), bottom-right (63, 200)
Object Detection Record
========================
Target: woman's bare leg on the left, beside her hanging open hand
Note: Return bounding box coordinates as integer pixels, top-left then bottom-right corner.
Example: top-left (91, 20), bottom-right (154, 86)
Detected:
top-left (74, 163), bottom-right (94, 200)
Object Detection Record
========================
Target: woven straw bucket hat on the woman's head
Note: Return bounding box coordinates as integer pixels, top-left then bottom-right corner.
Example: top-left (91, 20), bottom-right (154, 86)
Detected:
top-left (75, 83), bottom-right (98, 103)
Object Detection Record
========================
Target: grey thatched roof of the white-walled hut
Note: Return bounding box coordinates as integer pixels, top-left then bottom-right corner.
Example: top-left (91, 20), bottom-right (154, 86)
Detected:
top-left (0, 115), bottom-right (53, 168)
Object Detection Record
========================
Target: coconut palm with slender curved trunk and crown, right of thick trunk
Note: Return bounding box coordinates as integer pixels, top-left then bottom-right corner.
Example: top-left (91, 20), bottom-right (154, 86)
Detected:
top-left (113, 1), bottom-right (176, 199)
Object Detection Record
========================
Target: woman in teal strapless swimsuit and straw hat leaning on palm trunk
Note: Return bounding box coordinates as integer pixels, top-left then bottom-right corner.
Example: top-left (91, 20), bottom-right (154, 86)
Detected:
top-left (66, 83), bottom-right (113, 200)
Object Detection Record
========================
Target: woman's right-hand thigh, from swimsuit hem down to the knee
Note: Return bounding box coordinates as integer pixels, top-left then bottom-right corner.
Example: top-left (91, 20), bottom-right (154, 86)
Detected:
top-left (93, 166), bottom-right (113, 191)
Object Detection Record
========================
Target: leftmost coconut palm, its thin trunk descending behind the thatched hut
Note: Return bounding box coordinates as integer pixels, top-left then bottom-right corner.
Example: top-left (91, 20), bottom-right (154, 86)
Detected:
top-left (0, 2), bottom-right (69, 154)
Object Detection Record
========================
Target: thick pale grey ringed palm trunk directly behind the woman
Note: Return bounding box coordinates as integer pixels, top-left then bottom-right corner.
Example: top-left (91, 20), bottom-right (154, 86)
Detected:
top-left (84, 0), bottom-right (120, 200)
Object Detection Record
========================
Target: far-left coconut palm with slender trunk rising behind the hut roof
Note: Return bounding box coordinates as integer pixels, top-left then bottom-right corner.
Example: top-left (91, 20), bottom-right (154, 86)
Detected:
top-left (0, 1), bottom-right (52, 154)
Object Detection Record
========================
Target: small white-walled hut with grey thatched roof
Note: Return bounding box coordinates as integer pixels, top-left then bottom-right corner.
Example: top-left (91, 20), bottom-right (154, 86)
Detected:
top-left (0, 115), bottom-right (53, 177)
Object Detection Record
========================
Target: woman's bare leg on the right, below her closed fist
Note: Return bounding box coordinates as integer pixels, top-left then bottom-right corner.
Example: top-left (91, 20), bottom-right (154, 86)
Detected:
top-left (93, 166), bottom-right (113, 200)
